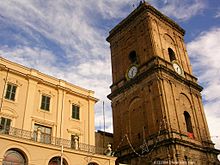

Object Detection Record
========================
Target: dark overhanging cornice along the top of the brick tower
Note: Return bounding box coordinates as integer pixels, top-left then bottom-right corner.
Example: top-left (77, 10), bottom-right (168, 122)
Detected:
top-left (107, 2), bottom-right (185, 41)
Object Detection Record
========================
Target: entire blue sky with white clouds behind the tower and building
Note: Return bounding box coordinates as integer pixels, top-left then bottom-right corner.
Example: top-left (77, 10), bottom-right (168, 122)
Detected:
top-left (0, 0), bottom-right (220, 152)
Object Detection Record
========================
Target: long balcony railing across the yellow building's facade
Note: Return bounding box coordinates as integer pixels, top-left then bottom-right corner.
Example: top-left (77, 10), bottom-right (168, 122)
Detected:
top-left (0, 127), bottom-right (105, 154)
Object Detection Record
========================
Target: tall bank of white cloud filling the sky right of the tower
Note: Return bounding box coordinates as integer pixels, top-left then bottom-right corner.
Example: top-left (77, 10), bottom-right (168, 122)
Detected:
top-left (187, 28), bottom-right (220, 148)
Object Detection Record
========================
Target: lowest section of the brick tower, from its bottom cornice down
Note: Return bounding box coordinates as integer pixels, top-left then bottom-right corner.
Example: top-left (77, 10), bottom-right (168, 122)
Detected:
top-left (116, 136), bottom-right (220, 165)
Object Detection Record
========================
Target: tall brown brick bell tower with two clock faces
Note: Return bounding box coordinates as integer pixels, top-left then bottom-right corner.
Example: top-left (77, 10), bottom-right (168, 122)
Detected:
top-left (107, 3), bottom-right (220, 165)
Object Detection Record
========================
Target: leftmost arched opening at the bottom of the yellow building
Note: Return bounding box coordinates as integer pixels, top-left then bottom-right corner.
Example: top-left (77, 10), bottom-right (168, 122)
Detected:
top-left (2, 149), bottom-right (27, 165)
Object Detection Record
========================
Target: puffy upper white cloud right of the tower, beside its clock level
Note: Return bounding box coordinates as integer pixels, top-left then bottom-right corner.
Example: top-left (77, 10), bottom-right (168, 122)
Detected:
top-left (188, 28), bottom-right (220, 84)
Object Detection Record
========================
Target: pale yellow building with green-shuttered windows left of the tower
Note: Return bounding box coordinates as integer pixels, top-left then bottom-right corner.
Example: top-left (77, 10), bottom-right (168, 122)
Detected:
top-left (0, 57), bottom-right (115, 165)
